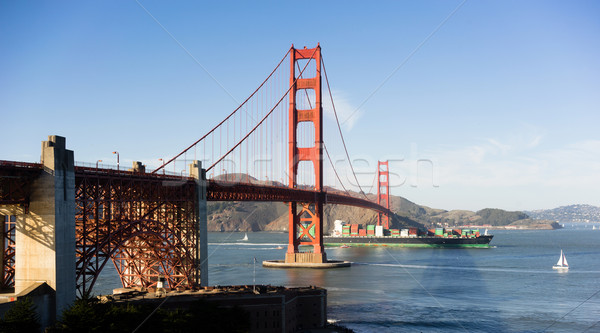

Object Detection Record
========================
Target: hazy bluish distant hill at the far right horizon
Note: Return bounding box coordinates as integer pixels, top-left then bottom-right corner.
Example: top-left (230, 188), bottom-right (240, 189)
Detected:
top-left (527, 205), bottom-right (600, 223)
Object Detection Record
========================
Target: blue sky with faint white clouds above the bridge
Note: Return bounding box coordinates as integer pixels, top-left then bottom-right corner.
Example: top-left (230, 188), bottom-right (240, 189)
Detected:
top-left (0, 0), bottom-right (600, 210)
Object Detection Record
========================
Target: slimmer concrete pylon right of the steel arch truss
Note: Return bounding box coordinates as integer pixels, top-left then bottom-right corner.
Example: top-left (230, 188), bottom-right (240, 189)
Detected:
top-left (190, 161), bottom-right (208, 287)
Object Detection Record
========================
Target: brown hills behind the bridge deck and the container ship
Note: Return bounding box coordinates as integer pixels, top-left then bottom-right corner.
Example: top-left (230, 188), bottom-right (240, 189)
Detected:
top-left (208, 175), bottom-right (557, 233)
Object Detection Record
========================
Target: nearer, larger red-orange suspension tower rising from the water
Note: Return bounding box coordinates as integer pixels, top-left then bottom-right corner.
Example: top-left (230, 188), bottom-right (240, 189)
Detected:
top-left (285, 45), bottom-right (327, 263)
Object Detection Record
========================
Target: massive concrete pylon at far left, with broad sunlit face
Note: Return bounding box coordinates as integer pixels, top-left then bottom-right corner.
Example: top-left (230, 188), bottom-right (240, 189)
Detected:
top-left (15, 136), bottom-right (76, 317)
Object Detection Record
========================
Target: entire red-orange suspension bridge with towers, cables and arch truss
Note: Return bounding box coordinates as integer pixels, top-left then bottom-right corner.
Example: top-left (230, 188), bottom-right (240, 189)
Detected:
top-left (0, 45), bottom-right (394, 295)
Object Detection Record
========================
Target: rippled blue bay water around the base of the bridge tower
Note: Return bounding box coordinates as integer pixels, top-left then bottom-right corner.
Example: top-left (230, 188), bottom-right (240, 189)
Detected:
top-left (95, 227), bottom-right (600, 332)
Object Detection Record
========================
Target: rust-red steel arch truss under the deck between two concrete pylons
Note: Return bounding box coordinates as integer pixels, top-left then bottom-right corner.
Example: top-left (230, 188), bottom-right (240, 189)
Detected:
top-left (75, 168), bottom-right (199, 295)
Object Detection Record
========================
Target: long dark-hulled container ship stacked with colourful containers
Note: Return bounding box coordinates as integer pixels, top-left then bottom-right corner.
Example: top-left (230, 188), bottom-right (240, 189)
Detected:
top-left (323, 220), bottom-right (494, 248)
